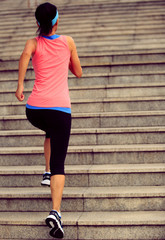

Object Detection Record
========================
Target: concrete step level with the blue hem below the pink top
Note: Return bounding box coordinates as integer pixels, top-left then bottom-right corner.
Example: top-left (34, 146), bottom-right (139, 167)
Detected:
top-left (0, 96), bottom-right (165, 116)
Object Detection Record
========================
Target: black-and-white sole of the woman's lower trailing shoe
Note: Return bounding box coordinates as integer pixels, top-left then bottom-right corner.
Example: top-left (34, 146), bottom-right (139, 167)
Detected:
top-left (45, 216), bottom-right (64, 238)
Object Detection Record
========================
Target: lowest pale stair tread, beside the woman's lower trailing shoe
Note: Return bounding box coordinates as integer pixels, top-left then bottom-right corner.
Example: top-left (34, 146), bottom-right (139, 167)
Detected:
top-left (0, 211), bottom-right (165, 226)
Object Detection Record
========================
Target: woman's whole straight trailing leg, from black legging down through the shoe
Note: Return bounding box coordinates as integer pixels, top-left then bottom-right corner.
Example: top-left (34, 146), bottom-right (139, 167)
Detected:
top-left (46, 111), bottom-right (71, 238)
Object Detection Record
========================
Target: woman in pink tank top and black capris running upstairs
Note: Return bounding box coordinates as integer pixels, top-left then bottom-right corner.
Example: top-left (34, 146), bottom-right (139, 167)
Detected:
top-left (15, 3), bottom-right (82, 238)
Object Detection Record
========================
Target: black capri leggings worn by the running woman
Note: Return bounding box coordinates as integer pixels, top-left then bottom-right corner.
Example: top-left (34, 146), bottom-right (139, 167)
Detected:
top-left (26, 108), bottom-right (71, 175)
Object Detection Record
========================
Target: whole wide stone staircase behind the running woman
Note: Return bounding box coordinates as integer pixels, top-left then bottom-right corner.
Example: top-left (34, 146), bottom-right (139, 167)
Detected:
top-left (0, 0), bottom-right (165, 240)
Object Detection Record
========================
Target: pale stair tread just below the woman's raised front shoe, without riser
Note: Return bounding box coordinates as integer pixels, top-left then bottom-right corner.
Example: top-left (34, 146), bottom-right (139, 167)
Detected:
top-left (0, 186), bottom-right (165, 199)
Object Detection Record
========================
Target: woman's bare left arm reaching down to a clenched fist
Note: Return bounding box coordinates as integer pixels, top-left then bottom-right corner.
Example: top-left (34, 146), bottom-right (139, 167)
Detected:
top-left (15, 38), bottom-right (37, 101)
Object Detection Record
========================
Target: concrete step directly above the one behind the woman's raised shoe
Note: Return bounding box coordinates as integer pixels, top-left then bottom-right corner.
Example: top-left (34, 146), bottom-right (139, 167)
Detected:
top-left (0, 144), bottom-right (165, 166)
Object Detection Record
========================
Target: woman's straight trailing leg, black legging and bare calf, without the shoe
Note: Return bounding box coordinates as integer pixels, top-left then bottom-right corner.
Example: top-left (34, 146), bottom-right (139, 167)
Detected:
top-left (50, 111), bottom-right (71, 211)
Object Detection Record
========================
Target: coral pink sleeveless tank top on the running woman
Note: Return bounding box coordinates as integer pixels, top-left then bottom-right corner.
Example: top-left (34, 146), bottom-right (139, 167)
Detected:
top-left (27, 35), bottom-right (71, 108)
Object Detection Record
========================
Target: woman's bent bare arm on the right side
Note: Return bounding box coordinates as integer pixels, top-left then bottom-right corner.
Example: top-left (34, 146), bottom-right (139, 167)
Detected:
top-left (67, 36), bottom-right (82, 78)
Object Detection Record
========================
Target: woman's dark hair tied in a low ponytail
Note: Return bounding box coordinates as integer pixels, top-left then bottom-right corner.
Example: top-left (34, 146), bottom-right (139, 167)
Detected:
top-left (35, 2), bottom-right (57, 36)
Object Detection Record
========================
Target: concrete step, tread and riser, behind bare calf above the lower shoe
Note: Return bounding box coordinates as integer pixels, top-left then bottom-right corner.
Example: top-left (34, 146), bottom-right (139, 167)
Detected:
top-left (0, 186), bottom-right (165, 212)
